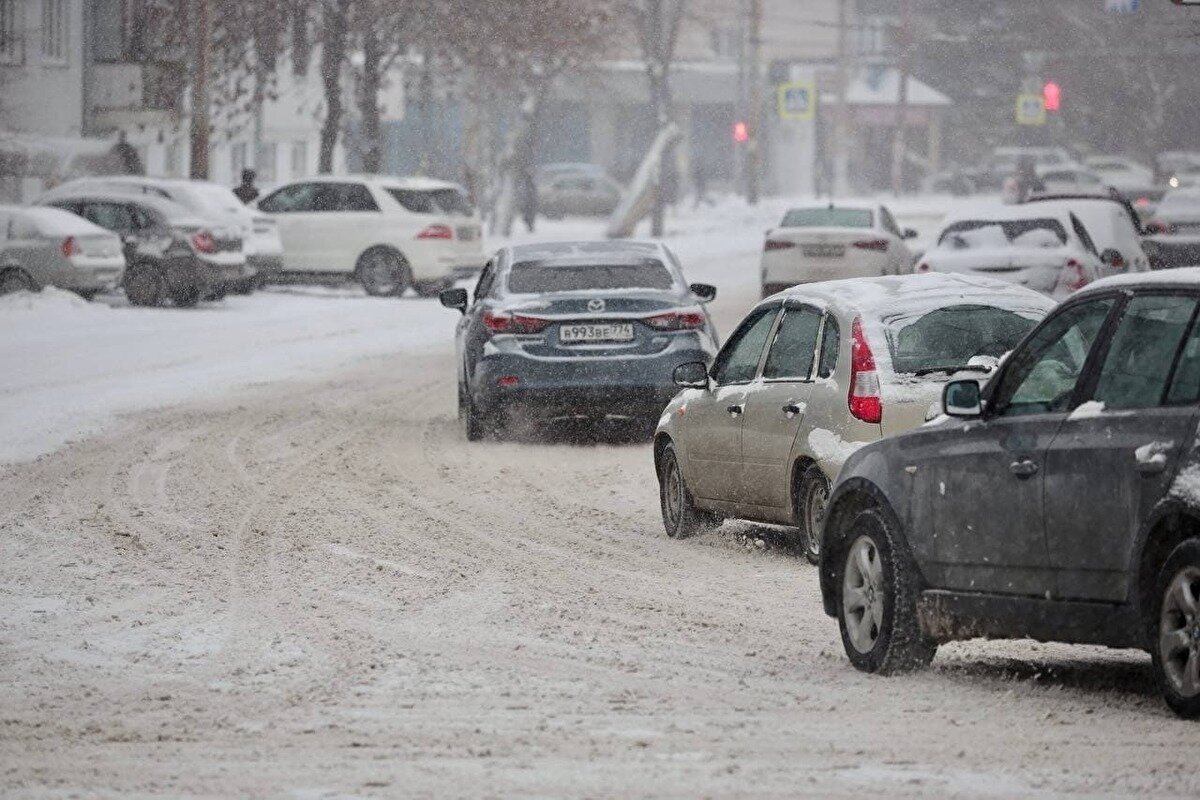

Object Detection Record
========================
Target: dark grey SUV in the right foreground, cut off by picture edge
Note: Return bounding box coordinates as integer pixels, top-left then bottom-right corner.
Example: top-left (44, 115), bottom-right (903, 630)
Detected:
top-left (821, 270), bottom-right (1200, 717)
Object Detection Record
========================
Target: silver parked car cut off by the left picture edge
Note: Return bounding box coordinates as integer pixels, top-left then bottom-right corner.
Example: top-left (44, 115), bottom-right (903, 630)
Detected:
top-left (0, 205), bottom-right (125, 300)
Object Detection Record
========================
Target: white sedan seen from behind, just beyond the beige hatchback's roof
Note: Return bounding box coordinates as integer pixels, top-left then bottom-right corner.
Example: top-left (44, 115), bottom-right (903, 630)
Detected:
top-left (761, 203), bottom-right (917, 297)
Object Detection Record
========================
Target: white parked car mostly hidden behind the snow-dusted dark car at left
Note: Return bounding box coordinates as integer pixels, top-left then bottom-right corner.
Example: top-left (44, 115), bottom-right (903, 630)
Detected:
top-left (42, 175), bottom-right (283, 294)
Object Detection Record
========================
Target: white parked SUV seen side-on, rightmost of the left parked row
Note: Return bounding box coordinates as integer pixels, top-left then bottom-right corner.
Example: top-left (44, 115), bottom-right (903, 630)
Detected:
top-left (258, 175), bottom-right (486, 296)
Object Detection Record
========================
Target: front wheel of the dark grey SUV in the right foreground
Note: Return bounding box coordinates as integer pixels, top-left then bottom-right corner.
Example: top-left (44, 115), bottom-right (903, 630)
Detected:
top-left (838, 509), bottom-right (937, 674)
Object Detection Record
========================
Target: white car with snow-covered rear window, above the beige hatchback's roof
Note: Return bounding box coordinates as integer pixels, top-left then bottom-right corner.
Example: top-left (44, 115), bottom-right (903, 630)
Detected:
top-left (917, 203), bottom-right (1123, 299)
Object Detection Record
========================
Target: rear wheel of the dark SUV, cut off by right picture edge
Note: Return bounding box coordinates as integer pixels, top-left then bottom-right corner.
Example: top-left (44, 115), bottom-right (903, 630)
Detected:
top-left (1151, 539), bottom-right (1200, 720)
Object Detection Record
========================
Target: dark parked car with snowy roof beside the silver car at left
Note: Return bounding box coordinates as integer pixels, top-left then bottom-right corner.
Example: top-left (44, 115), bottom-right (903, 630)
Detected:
top-left (44, 191), bottom-right (246, 306)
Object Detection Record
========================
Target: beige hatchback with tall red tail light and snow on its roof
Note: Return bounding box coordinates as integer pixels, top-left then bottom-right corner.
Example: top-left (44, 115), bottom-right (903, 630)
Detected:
top-left (654, 273), bottom-right (1055, 563)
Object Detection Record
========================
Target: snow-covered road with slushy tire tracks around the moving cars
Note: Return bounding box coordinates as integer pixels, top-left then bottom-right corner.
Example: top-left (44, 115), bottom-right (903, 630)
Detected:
top-left (0, 199), bottom-right (1200, 798)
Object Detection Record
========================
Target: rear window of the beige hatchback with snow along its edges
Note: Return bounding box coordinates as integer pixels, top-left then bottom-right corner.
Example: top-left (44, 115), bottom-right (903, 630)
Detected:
top-left (884, 305), bottom-right (1040, 373)
